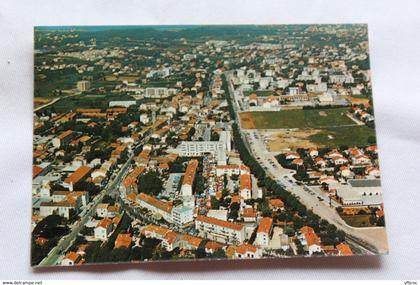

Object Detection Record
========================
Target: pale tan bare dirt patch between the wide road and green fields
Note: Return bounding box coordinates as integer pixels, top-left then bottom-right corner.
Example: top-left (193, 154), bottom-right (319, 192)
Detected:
top-left (261, 129), bottom-right (320, 152)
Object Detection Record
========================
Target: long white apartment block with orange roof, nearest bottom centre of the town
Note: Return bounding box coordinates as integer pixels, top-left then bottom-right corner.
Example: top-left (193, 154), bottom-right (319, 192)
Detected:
top-left (195, 215), bottom-right (245, 244)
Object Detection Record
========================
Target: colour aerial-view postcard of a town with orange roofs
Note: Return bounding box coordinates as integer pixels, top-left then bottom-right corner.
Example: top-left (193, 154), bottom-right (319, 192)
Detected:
top-left (28, 24), bottom-right (388, 267)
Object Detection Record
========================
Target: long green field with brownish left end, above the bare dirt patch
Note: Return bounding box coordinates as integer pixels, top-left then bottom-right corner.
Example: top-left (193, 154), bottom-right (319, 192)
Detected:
top-left (252, 108), bottom-right (355, 129)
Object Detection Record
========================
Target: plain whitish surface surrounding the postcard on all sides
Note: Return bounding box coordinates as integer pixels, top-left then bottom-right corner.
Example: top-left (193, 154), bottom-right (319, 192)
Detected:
top-left (0, 0), bottom-right (420, 280)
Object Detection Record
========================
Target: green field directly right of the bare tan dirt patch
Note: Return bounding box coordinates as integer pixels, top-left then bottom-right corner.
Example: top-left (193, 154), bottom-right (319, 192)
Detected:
top-left (308, 126), bottom-right (376, 147)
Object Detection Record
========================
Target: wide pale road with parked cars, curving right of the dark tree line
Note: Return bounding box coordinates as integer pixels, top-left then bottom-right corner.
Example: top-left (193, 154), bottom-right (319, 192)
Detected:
top-left (225, 72), bottom-right (388, 254)
